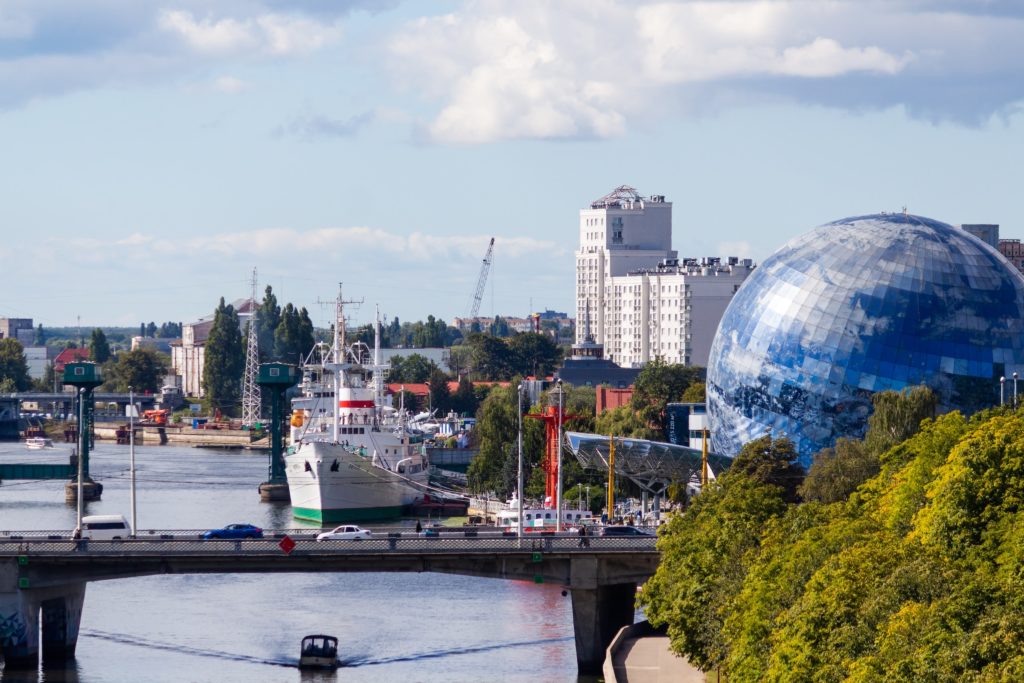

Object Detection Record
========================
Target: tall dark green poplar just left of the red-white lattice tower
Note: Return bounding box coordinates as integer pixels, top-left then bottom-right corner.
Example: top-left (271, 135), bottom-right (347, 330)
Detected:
top-left (203, 297), bottom-right (246, 415)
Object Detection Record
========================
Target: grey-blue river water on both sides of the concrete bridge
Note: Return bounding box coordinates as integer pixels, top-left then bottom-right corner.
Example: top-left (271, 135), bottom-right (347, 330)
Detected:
top-left (0, 442), bottom-right (595, 683)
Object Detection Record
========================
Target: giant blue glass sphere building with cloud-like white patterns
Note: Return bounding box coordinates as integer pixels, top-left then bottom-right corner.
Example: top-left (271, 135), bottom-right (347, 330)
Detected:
top-left (708, 214), bottom-right (1024, 466)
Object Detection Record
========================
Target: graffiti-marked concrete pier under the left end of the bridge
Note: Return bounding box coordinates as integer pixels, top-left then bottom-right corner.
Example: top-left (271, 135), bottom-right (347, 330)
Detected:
top-left (0, 561), bottom-right (85, 671)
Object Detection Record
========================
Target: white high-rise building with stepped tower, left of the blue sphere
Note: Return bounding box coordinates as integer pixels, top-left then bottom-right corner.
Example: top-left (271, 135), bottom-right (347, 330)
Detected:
top-left (577, 185), bottom-right (754, 368)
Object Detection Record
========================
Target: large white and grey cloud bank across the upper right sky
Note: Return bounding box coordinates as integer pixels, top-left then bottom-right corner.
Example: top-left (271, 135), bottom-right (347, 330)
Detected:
top-left (387, 0), bottom-right (1024, 143)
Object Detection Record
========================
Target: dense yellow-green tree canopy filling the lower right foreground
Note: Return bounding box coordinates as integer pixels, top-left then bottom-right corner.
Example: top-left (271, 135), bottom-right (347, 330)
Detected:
top-left (641, 403), bottom-right (1024, 683)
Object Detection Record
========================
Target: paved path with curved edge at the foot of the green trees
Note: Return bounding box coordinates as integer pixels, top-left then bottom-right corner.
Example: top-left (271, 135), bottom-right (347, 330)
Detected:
top-left (605, 622), bottom-right (705, 683)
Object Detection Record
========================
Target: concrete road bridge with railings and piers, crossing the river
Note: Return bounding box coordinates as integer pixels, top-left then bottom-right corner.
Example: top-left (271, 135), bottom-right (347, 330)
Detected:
top-left (0, 530), bottom-right (658, 674)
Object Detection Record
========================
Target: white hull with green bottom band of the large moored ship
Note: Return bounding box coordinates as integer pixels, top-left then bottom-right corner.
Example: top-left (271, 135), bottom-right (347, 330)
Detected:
top-left (285, 441), bottom-right (427, 524)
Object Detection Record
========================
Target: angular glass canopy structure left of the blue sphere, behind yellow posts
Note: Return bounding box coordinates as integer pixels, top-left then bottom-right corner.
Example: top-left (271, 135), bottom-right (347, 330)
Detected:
top-left (565, 432), bottom-right (732, 494)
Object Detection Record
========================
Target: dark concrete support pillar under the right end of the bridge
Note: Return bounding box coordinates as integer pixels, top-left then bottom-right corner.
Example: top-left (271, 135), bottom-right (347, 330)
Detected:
top-left (569, 558), bottom-right (637, 674)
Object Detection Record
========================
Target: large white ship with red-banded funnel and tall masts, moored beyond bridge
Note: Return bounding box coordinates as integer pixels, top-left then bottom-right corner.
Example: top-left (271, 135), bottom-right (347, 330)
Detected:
top-left (285, 296), bottom-right (429, 524)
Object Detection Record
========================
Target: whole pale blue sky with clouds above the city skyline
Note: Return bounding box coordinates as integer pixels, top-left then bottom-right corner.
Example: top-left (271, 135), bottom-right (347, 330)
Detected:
top-left (0, 0), bottom-right (1024, 328)
